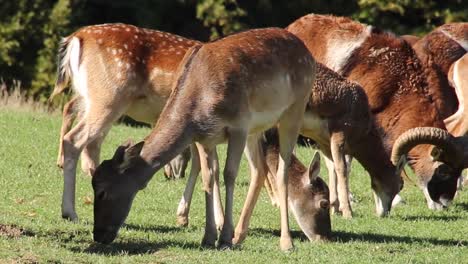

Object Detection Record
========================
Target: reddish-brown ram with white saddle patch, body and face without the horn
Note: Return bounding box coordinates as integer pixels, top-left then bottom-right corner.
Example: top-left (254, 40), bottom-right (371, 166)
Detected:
top-left (287, 14), bottom-right (466, 210)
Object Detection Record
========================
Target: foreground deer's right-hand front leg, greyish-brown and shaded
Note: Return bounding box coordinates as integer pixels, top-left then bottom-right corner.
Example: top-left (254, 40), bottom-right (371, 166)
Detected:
top-left (218, 130), bottom-right (247, 249)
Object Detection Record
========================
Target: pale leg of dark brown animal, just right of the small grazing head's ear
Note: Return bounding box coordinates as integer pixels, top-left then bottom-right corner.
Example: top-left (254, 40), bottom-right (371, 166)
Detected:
top-left (330, 132), bottom-right (353, 218)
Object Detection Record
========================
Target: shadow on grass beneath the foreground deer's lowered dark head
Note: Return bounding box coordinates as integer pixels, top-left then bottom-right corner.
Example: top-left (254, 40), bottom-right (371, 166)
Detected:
top-left (70, 240), bottom-right (203, 256)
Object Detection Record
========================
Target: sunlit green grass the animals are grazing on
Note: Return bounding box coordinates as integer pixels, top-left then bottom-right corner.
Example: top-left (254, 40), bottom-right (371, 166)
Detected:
top-left (0, 108), bottom-right (468, 263)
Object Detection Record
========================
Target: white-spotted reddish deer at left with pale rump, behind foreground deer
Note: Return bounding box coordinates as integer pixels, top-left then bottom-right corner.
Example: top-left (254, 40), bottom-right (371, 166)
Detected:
top-left (51, 24), bottom-right (221, 220)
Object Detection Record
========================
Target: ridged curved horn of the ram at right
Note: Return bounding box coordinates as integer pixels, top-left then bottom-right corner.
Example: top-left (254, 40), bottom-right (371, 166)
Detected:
top-left (392, 127), bottom-right (463, 165)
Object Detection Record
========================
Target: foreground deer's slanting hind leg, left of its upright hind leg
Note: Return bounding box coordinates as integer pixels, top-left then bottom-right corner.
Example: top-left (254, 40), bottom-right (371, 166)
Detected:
top-left (233, 134), bottom-right (266, 244)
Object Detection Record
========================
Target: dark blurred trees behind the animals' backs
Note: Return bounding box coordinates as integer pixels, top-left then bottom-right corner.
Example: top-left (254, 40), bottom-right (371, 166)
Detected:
top-left (0, 0), bottom-right (468, 104)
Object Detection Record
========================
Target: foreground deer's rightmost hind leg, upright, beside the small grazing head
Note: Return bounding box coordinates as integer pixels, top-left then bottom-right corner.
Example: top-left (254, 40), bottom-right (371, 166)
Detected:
top-left (276, 104), bottom-right (305, 251)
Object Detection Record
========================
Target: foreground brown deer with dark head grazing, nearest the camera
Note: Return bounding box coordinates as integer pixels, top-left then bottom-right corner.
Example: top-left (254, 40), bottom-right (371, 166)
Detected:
top-left (92, 28), bottom-right (315, 250)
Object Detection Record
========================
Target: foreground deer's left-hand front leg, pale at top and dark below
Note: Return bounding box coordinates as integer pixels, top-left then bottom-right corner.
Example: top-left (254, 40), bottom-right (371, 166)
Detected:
top-left (196, 143), bottom-right (218, 248)
